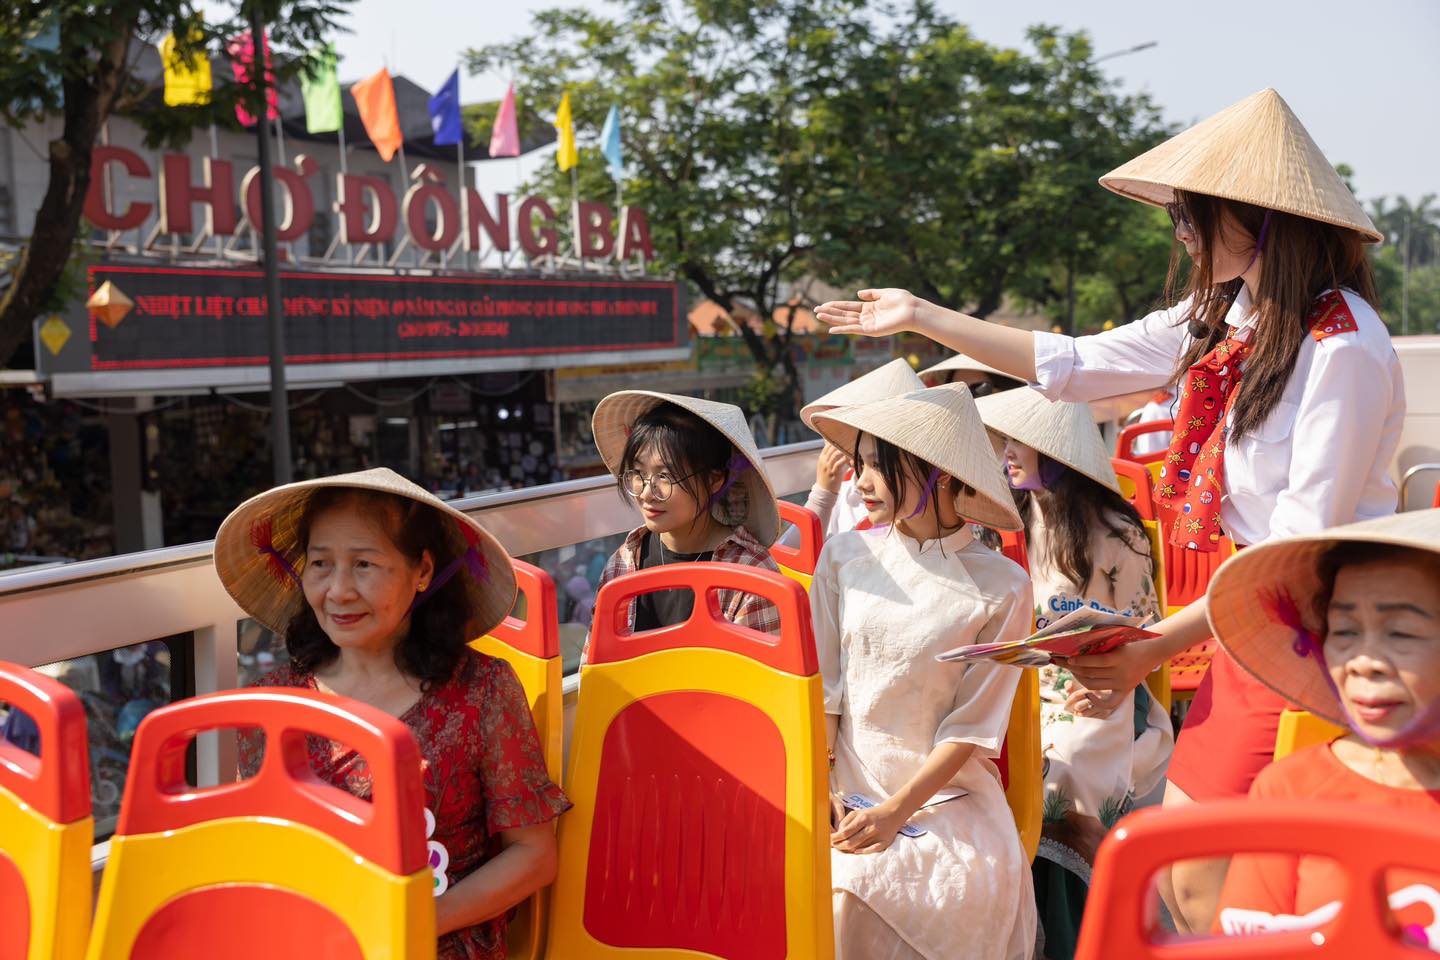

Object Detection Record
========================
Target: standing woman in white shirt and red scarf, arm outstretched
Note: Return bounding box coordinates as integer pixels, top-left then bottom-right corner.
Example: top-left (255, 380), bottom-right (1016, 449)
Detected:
top-left (816, 89), bottom-right (1404, 930)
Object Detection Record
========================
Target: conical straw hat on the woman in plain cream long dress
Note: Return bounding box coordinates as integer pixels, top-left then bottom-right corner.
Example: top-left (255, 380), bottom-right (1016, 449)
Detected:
top-left (815, 383), bottom-right (1024, 530)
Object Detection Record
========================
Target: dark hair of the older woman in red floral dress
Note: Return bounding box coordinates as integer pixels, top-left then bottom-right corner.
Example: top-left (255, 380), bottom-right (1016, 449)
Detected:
top-left (285, 486), bottom-right (475, 691)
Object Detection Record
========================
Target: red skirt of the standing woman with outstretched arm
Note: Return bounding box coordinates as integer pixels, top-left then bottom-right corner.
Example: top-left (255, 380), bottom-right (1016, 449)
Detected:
top-left (1166, 646), bottom-right (1286, 802)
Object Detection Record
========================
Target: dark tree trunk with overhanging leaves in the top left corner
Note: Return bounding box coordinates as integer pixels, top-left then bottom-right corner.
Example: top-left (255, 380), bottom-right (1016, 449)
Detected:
top-left (0, 0), bottom-right (350, 363)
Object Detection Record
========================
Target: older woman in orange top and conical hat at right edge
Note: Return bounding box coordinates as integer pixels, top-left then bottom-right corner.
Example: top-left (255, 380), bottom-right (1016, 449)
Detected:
top-left (1210, 510), bottom-right (1440, 951)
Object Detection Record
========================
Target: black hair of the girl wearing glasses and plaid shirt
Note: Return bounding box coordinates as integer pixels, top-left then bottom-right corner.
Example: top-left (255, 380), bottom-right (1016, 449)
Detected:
top-left (615, 403), bottom-right (744, 527)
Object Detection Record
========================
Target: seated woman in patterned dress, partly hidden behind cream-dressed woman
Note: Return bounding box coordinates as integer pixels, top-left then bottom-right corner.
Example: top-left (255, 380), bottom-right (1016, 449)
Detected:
top-left (975, 389), bottom-right (1175, 960)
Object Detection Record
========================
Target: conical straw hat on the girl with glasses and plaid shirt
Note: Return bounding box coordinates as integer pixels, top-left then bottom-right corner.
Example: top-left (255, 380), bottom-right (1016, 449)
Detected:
top-left (590, 390), bottom-right (780, 547)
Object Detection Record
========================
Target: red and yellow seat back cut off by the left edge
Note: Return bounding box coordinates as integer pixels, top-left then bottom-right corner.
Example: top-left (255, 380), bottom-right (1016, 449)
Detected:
top-left (0, 661), bottom-right (95, 960)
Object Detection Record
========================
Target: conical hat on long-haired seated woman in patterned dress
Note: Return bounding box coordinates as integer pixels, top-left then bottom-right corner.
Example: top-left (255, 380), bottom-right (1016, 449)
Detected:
top-left (975, 389), bottom-right (1120, 494)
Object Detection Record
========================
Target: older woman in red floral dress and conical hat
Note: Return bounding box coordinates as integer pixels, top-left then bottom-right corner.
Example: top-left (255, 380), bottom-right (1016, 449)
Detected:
top-left (215, 469), bottom-right (570, 960)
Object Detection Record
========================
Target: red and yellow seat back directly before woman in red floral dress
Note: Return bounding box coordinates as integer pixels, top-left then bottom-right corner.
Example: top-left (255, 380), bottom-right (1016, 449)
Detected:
top-left (86, 688), bottom-right (435, 960)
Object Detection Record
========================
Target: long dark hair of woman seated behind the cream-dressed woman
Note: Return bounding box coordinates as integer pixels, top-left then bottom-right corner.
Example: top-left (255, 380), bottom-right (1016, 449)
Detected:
top-left (1015, 450), bottom-right (1155, 599)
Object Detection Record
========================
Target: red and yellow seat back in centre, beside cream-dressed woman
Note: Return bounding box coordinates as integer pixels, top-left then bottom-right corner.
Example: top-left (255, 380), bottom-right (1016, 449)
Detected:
top-left (549, 563), bottom-right (834, 960)
